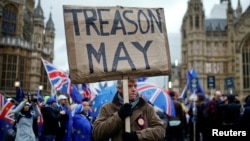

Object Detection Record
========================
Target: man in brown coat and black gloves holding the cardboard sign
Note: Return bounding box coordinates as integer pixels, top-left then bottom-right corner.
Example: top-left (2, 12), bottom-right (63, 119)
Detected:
top-left (93, 79), bottom-right (165, 141)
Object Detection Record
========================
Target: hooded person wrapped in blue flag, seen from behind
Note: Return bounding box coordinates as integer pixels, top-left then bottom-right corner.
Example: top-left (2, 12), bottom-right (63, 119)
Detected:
top-left (72, 104), bottom-right (92, 141)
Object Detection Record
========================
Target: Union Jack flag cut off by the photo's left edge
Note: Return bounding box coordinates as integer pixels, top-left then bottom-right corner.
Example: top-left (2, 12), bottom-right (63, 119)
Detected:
top-left (0, 93), bottom-right (15, 141)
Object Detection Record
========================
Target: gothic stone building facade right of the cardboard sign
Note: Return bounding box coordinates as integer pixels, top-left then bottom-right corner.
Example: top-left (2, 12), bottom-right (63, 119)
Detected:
top-left (180, 0), bottom-right (250, 99)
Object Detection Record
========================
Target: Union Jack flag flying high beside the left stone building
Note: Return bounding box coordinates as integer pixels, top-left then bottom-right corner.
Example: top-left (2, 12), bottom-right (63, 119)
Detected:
top-left (42, 59), bottom-right (82, 103)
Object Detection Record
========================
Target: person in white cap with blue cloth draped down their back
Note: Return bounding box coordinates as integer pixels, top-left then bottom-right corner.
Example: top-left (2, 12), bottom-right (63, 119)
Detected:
top-left (56, 94), bottom-right (72, 141)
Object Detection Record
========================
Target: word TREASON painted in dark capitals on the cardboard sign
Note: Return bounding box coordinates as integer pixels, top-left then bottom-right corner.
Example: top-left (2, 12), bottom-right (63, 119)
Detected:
top-left (64, 8), bottom-right (162, 36)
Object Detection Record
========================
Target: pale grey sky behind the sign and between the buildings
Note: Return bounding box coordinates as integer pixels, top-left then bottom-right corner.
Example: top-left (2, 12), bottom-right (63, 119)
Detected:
top-left (39, 0), bottom-right (250, 70)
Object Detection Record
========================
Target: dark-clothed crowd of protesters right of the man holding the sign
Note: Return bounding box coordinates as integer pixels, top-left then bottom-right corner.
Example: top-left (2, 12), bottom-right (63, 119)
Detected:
top-left (162, 91), bottom-right (250, 141)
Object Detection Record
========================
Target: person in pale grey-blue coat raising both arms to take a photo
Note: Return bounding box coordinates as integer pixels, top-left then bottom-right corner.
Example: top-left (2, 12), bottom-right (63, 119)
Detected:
top-left (12, 101), bottom-right (41, 141)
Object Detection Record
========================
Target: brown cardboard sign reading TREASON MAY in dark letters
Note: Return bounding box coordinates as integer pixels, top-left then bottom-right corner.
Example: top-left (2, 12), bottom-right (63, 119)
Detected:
top-left (63, 6), bottom-right (171, 83)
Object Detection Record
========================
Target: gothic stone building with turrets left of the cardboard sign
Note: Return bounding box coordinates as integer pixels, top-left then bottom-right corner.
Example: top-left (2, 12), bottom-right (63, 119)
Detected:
top-left (0, 0), bottom-right (55, 95)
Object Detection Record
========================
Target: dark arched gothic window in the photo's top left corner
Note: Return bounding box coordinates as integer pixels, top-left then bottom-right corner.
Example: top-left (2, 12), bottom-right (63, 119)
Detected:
top-left (2, 4), bottom-right (18, 36)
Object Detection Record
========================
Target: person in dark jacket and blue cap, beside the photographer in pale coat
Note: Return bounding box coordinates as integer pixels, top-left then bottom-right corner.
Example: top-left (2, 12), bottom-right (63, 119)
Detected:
top-left (41, 97), bottom-right (67, 141)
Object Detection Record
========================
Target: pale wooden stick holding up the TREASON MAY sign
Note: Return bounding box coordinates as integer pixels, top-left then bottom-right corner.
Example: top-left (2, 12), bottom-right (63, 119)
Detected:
top-left (123, 79), bottom-right (131, 132)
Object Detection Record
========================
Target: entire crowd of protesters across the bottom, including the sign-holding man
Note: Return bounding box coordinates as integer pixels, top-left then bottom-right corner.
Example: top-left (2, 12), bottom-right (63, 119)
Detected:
top-left (3, 81), bottom-right (250, 141)
